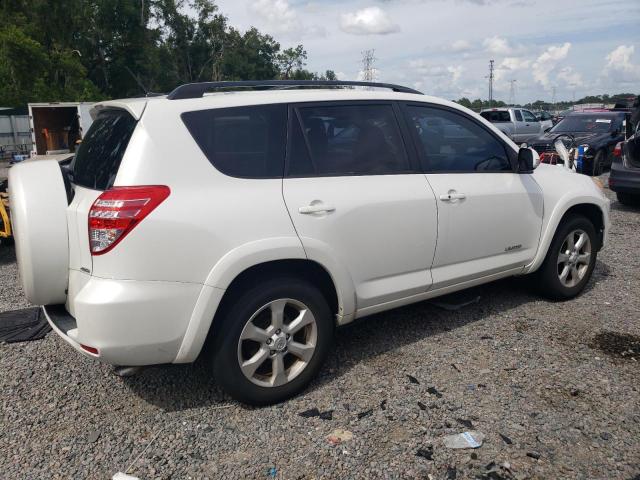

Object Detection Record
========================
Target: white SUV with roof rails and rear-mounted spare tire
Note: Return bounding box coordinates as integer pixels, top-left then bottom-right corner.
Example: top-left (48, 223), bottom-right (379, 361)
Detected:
top-left (9, 81), bottom-right (609, 404)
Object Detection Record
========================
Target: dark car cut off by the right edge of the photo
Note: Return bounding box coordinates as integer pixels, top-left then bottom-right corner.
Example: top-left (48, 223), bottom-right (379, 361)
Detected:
top-left (609, 123), bottom-right (640, 205)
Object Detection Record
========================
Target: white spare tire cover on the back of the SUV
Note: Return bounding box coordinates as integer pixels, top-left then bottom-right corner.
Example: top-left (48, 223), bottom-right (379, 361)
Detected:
top-left (9, 160), bottom-right (69, 305)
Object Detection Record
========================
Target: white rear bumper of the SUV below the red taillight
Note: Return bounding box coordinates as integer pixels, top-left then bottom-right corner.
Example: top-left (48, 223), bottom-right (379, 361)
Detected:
top-left (43, 272), bottom-right (202, 366)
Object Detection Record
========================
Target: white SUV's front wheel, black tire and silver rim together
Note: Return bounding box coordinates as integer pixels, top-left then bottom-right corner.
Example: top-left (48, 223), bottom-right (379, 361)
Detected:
top-left (535, 215), bottom-right (598, 300)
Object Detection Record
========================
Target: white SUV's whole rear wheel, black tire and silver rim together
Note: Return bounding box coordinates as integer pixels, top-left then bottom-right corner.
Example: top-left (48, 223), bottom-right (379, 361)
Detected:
top-left (213, 278), bottom-right (334, 405)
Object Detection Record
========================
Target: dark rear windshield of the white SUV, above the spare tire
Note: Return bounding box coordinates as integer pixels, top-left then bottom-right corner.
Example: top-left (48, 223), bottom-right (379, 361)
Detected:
top-left (71, 110), bottom-right (136, 190)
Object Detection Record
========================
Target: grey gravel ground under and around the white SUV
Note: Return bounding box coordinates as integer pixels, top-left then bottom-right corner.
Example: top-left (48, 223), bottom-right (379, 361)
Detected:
top-left (0, 173), bottom-right (640, 480)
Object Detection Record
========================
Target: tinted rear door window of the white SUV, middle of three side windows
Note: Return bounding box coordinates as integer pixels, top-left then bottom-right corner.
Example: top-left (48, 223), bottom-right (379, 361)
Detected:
top-left (288, 105), bottom-right (410, 176)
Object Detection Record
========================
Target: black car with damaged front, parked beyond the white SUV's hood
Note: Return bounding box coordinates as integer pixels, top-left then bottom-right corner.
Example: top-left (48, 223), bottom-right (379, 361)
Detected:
top-left (530, 111), bottom-right (629, 175)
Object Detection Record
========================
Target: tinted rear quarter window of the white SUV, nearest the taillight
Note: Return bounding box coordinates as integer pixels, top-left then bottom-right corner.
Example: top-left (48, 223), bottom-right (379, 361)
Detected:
top-left (182, 105), bottom-right (287, 178)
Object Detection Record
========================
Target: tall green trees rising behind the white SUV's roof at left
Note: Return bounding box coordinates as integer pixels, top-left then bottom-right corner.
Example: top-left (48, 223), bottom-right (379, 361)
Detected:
top-left (0, 0), bottom-right (336, 107)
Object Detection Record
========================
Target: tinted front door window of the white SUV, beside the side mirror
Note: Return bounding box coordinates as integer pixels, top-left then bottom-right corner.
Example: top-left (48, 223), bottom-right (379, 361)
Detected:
top-left (408, 106), bottom-right (512, 172)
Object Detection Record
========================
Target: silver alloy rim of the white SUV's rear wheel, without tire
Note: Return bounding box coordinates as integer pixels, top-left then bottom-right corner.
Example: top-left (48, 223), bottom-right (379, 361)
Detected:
top-left (238, 298), bottom-right (318, 387)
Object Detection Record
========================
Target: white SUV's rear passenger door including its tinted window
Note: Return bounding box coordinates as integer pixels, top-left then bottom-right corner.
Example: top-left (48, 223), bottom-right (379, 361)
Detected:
top-left (283, 102), bottom-right (437, 313)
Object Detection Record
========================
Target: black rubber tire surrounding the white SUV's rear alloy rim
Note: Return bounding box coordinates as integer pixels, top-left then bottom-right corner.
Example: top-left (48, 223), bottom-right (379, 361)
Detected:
top-left (210, 277), bottom-right (335, 406)
